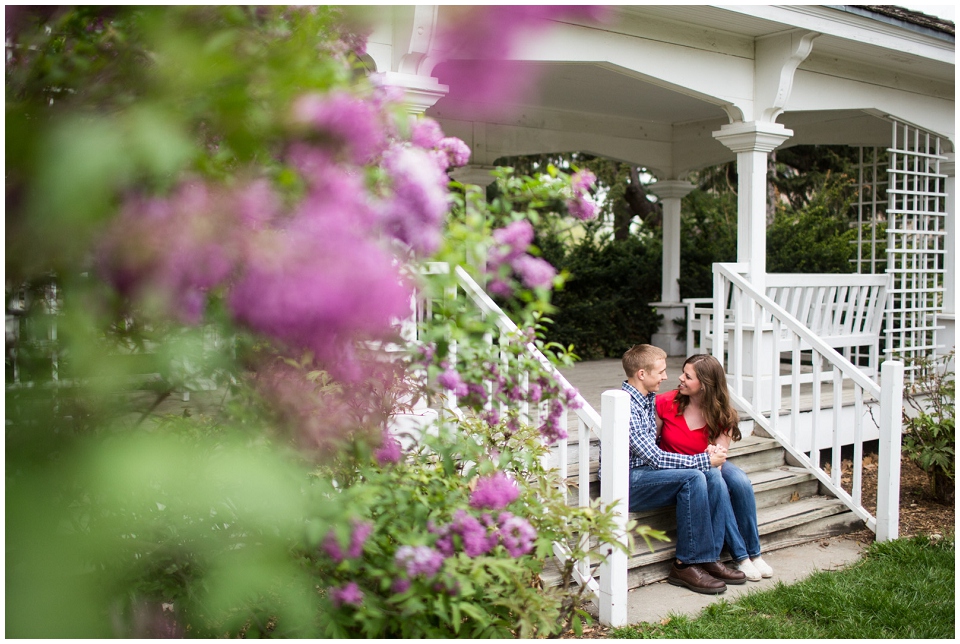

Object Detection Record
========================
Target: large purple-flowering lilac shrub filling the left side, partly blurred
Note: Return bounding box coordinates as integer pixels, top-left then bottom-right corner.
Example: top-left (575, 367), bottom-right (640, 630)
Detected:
top-left (6, 7), bottom-right (636, 637)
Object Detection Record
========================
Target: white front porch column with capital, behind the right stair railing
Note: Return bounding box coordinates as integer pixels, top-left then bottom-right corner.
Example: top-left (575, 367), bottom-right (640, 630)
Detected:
top-left (713, 121), bottom-right (793, 411)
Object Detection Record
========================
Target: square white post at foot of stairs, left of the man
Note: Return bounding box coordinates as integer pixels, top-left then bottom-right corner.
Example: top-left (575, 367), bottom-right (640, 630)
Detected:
top-left (598, 389), bottom-right (630, 626)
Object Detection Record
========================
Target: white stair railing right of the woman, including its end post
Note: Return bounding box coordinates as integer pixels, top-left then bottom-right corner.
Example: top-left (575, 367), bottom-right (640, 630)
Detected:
top-left (711, 264), bottom-right (904, 540)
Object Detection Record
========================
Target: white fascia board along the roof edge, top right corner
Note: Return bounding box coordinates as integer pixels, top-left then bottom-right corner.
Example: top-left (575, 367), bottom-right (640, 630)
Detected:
top-left (713, 5), bottom-right (955, 64)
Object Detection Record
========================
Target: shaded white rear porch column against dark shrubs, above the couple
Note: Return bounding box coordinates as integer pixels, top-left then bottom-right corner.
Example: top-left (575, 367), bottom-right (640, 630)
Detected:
top-left (647, 179), bottom-right (695, 356)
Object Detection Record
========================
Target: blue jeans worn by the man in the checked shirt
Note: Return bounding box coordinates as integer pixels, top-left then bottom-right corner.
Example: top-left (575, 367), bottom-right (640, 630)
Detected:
top-left (630, 467), bottom-right (729, 564)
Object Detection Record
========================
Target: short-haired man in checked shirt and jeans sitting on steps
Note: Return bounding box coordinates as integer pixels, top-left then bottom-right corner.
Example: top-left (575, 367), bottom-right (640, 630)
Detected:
top-left (621, 344), bottom-right (746, 595)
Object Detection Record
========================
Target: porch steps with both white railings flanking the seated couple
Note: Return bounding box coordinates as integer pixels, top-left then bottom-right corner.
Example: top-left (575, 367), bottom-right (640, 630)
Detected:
top-left (416, 264), bottom-right (903, 626)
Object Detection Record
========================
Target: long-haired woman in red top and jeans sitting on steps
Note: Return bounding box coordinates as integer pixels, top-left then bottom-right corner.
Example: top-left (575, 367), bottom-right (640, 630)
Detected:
top-left (656, 354), bottom-right (773, 581)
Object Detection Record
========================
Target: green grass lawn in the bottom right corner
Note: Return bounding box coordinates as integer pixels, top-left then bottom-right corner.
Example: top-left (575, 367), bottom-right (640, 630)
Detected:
top-left (611, 536), bottom-right (955, 639)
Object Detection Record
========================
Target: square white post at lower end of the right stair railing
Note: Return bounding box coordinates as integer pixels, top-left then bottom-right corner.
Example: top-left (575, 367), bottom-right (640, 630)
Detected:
top-left (877, 360), bottom-right (903, 541)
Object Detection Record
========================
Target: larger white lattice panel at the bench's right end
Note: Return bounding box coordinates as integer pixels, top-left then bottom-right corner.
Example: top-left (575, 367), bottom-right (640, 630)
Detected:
top-left (885, 121), bottom-right (946, 382)
